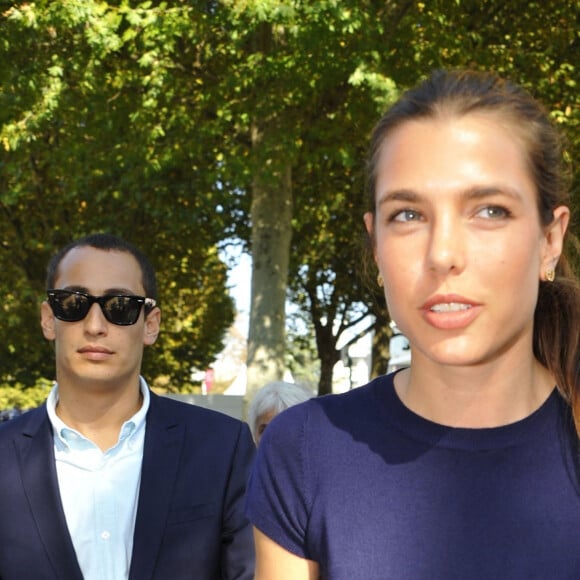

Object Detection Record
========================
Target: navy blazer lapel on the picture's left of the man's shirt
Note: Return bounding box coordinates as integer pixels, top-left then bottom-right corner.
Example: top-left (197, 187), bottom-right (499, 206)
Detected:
top-left (15, 406), bottom-right (82, 580)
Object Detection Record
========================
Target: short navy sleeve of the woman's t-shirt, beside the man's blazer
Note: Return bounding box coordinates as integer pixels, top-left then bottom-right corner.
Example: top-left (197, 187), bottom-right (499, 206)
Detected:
top-left (246, 403), bottom-right (311, 558)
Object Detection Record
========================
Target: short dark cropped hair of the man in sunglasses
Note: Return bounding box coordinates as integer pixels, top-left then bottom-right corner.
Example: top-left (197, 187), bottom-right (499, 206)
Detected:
top-left (46, 233), bottom-right (157, 300)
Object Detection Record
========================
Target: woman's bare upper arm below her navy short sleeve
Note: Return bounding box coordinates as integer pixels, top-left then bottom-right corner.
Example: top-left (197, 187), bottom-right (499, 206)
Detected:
top-left (254, 528), bottom-right (319, 580)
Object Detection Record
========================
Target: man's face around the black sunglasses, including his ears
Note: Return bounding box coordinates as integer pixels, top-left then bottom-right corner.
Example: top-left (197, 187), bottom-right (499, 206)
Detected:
top-left (41, 247), bottom-right (160, 391)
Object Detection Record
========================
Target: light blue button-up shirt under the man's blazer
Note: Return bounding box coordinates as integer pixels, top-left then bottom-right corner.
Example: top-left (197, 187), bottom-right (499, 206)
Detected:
top-left (46, 377), bottom-right (149, 580)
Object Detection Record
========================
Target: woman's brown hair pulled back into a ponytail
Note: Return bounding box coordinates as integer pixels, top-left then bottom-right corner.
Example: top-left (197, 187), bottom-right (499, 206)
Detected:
top-left (367, 71), bottom-right (580, 435)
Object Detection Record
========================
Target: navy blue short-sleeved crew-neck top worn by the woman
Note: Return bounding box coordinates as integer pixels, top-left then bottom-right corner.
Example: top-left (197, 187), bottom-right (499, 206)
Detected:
top-left (247, 375), bottom-right (580, 580)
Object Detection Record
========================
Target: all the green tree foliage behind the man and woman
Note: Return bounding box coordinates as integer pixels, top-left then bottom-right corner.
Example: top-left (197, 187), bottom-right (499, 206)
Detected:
top-left (0, 0), bottom-right (580, 392)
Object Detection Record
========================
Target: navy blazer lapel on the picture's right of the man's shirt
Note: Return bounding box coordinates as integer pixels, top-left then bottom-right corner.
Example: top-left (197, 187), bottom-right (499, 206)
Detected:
top-left (129, 393), bottom-right (183, 580)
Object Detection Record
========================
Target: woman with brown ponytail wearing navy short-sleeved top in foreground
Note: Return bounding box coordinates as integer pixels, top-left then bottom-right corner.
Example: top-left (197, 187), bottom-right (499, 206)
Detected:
top-left (248, 71), bottom-right (580, 580)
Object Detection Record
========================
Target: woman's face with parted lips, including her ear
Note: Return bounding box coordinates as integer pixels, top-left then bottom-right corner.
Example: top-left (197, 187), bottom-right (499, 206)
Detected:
top-left (365, 114), bottom-right (569, 366)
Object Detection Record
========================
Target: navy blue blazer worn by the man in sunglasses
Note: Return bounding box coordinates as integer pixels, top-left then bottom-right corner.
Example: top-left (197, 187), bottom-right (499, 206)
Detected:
top-left (0, 393), bottom-right (255, 580)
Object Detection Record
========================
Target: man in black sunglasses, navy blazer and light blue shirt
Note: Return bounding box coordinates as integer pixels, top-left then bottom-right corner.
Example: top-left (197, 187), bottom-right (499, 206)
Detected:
top-left (0, 234), bottom-right (254, 580)
